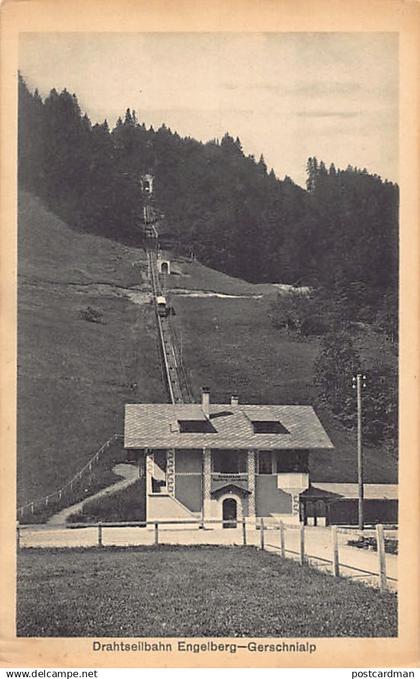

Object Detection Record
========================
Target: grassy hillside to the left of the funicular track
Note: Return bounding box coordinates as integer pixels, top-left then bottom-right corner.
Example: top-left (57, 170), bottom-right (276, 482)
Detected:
top-left (18, 193), bottom-right (166, 504)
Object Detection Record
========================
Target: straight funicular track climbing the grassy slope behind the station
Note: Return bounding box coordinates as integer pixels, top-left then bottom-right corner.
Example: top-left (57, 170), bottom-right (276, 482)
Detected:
top-left (146, 234), bottom-right (193, 403)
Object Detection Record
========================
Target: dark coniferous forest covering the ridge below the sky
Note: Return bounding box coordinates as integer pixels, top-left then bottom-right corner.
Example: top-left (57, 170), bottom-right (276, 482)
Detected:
top-left (18, 77), bottom-right (398, 452)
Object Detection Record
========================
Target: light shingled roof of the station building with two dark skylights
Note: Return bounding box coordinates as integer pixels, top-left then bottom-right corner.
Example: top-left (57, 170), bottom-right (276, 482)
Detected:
top-left (124, 403), bottom-right (333, 450)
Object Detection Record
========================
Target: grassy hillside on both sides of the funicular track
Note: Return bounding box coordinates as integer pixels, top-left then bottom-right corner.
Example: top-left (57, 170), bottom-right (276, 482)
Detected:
top-left (18, 193), bottom-right (396, 516)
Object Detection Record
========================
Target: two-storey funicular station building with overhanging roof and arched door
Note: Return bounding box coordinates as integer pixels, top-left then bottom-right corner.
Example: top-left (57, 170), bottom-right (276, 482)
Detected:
top-left (124, 388), bottom-right (333, 525)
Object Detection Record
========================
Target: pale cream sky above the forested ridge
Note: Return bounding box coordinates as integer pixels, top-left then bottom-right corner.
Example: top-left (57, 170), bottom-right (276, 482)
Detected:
top-left (19, 32), bottom-right (398, 186)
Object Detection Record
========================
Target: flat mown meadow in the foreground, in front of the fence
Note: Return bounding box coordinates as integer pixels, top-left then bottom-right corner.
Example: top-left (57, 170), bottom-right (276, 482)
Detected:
top-left (17, 546), bottom-right (397, 637)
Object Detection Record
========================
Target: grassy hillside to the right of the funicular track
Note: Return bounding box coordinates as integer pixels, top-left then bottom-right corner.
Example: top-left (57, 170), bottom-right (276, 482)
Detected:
top-left (167, 259), bottom-right (397, 483)
